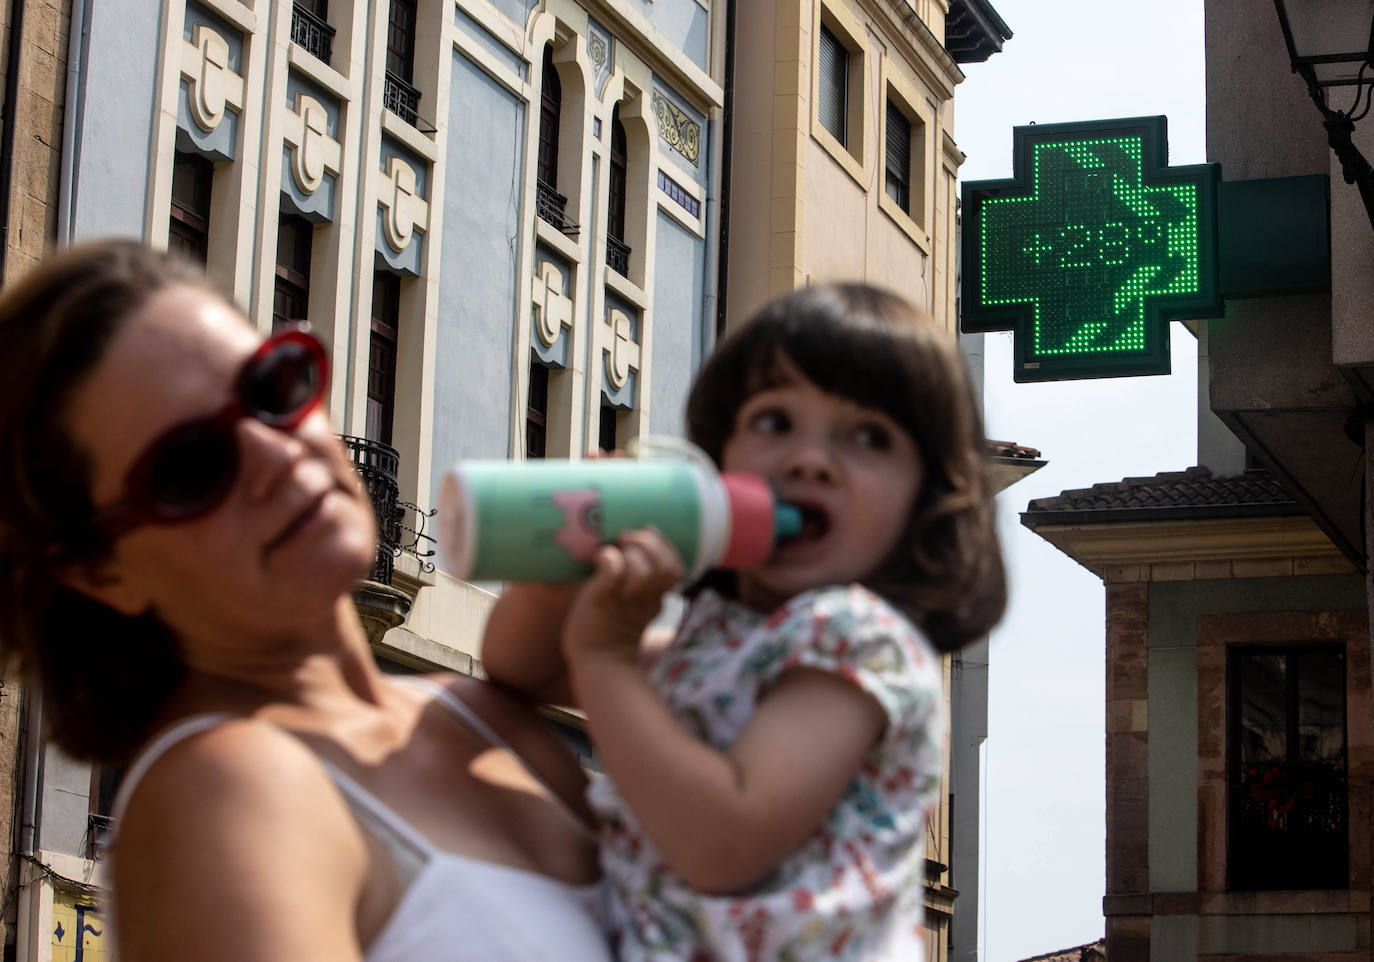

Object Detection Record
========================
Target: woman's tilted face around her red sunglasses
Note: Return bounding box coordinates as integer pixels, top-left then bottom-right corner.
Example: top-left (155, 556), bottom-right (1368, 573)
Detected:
top-left (67, 284), bottom-right (375, 642)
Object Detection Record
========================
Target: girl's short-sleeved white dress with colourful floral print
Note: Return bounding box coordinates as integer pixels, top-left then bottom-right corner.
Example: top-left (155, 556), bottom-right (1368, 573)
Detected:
top-left (589, 585), bottom-right (945, 962)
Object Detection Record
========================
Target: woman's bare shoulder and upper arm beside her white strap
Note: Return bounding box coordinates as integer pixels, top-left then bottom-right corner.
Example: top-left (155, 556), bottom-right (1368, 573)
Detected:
top-left (114, 722), bottom-right (368, 962)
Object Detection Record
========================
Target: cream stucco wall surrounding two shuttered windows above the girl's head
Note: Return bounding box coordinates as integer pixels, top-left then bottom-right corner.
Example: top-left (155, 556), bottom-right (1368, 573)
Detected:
top-left (727, 0), bottom-right (963, 333)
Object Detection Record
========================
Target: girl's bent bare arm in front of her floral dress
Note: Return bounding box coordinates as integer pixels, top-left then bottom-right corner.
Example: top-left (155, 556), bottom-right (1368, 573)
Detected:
top-left (563, 535), bottom-right (886, 893)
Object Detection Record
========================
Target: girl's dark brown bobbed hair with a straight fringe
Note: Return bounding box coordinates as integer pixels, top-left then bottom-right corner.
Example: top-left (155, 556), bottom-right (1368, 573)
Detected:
top-left (687, 283), bottom-right (1007, 651)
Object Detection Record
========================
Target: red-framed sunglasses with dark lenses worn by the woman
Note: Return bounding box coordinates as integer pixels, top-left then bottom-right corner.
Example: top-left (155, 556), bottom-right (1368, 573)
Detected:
top-left (91, 327), bottom-right (330, 541)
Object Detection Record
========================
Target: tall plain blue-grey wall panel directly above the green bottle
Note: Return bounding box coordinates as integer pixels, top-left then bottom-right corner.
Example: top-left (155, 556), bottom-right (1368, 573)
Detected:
top-left (433, 47), bottom-right (529, 491)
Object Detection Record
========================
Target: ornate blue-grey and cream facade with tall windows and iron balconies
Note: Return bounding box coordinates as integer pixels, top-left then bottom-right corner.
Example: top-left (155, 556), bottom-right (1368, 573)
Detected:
top-left (13, 0), bottom-right (724, 962)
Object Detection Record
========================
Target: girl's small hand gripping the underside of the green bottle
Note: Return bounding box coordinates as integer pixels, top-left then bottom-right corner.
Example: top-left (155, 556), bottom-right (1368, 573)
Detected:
top-left (563, 528), bottom-right (684, 661)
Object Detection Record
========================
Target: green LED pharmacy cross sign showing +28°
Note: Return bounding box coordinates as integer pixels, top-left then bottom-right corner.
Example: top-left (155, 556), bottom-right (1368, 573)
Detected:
top-left (962, 117), bottom-right (1221, 381)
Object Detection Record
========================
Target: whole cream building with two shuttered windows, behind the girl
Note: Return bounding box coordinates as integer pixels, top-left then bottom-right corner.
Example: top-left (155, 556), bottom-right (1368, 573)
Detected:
top-left (720, 0), bottom-right (1016, 962)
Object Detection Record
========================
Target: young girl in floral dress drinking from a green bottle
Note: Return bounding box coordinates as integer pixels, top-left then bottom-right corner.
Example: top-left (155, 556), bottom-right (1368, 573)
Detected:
top-left (484, 284), bottom-right (1006, 962)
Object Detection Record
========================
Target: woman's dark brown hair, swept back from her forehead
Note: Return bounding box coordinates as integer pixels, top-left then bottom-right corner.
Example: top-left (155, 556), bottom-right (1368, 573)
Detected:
top-left (0, 241), bottom-right (207, 761)
